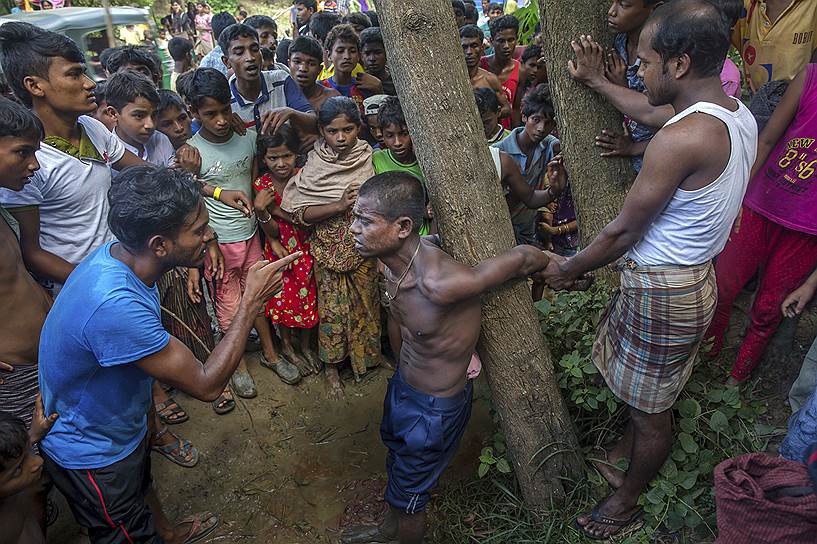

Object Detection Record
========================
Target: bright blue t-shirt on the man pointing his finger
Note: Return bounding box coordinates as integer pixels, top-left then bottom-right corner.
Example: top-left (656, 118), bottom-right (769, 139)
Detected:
top-left (39, 242), bottom-right (170, 470)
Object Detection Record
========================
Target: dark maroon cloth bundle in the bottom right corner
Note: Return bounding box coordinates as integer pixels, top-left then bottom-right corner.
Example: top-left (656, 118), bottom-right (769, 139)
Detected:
top-left (715, 453), bottom-right (817, 544)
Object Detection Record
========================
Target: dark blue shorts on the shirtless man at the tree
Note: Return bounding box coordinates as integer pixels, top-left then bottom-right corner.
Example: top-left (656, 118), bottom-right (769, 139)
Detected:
top-left (380, 370), bottom-right (473, 514)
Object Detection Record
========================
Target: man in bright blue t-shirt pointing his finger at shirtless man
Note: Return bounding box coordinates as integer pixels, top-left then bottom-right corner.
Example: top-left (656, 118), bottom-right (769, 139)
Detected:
top-left (39, 166), bottom-right (300, 543)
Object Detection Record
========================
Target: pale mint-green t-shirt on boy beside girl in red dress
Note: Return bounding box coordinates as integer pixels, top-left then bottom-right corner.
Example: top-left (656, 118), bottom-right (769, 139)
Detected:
top-left (188, 130), bottom-right (257, 244)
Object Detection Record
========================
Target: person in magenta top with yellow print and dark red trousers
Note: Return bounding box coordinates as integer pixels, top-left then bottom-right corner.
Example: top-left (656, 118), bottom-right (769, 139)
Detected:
top-left (707, 64), bottom-right (817, 382)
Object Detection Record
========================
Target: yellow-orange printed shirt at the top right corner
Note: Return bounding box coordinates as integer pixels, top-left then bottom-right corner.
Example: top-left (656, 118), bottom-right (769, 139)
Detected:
top-left (732, 0), bottom-right (817, 92)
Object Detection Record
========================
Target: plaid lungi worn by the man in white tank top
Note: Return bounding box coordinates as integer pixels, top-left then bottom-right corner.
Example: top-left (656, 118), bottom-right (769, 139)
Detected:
top-left (593, 261), bottom-right (718, 414)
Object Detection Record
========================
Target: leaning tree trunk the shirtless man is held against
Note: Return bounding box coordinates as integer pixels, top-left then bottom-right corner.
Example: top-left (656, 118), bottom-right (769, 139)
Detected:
top-left (376, 0), bottom-right (581, 507)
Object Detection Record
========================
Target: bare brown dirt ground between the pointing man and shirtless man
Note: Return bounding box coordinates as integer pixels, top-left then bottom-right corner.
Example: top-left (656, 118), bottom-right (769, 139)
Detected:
top-left (48, 354), bottom-right (493, 544)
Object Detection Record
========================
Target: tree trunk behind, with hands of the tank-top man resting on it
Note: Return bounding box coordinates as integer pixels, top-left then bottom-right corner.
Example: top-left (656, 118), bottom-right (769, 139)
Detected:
top-left (539, 0), bottom-right (634, 262)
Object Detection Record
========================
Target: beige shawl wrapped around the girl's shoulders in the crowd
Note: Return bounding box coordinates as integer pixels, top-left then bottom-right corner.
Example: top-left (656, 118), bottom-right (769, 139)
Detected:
top-left (281, 138), bottom-right (374, 213)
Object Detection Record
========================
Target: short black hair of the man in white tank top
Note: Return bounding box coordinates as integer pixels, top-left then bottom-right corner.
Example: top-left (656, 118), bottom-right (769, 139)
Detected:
top-left (645, 0), bottom-right (730, 77)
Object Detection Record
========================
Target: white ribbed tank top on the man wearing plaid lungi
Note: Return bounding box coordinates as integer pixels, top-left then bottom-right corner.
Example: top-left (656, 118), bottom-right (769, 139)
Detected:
top-left (628, 100), bottom-right (757, 266)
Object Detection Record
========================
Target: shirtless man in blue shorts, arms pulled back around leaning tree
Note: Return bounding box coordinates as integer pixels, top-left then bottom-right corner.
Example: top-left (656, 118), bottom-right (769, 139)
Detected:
top-left (342, 171), bottom-right (584, 544)
